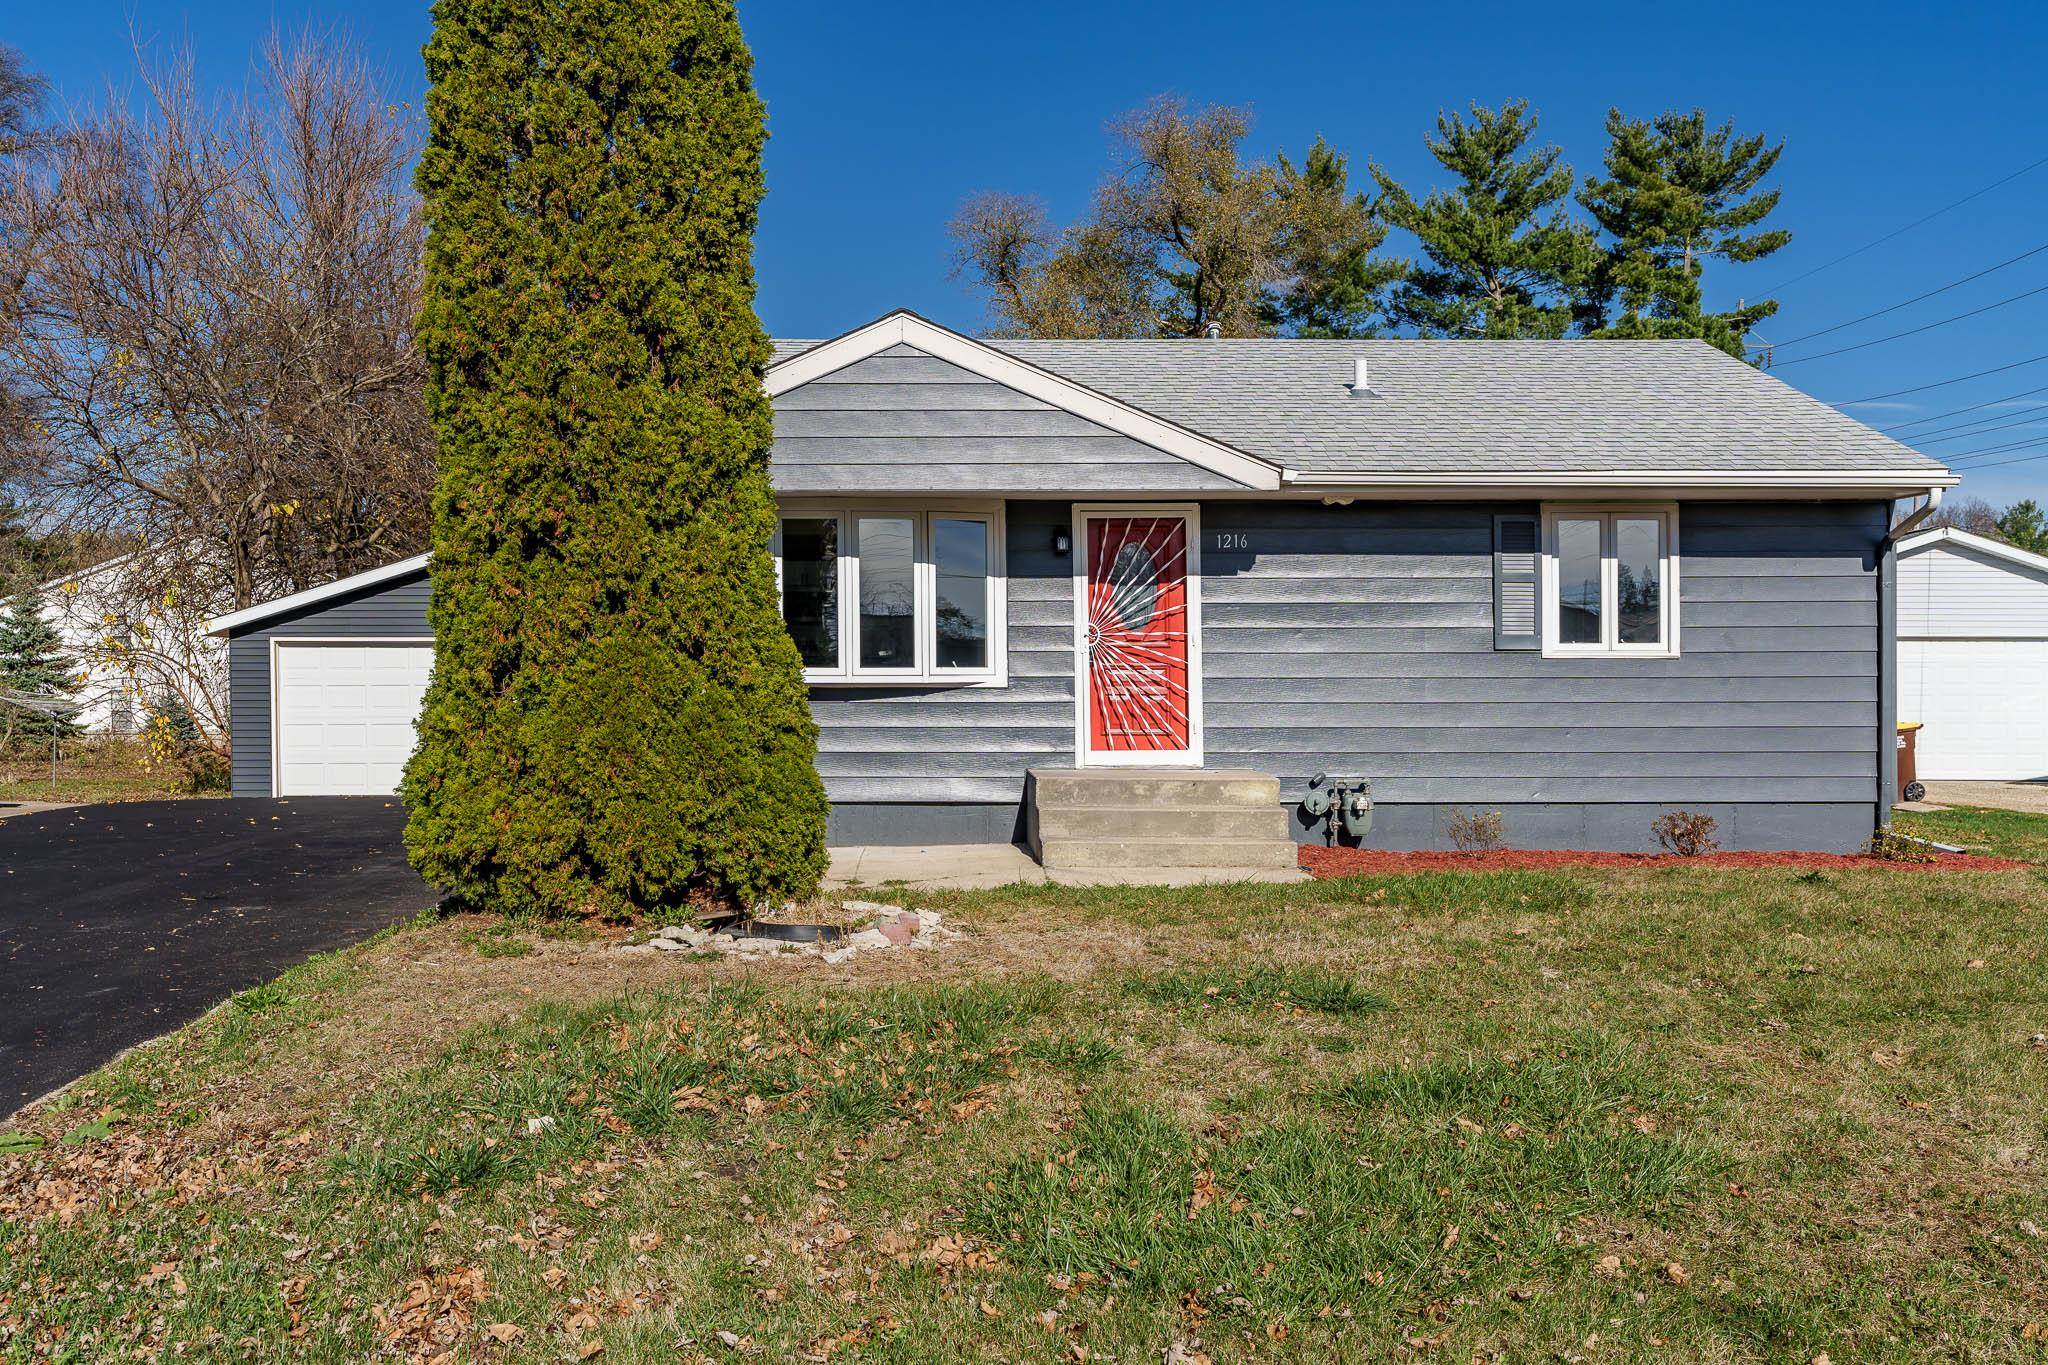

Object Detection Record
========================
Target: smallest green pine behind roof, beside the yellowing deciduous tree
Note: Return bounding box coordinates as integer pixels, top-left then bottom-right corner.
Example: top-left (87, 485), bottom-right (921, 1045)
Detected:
top-left (1266, 137), bottom-right (1407, 338)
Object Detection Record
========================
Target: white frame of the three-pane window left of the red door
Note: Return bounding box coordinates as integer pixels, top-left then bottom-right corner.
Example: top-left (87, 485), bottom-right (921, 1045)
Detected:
top-left (774, 499), bottom-right (1010, 688)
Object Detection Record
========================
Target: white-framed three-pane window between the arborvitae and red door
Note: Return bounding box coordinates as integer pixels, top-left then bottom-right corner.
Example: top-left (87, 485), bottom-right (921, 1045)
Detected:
top-left (776, 505), bottom-right (1006, 686)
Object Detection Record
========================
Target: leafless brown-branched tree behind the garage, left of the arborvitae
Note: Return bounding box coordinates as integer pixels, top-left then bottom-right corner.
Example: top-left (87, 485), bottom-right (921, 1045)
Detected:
top-left (0, 39), bottom-right (434, 732)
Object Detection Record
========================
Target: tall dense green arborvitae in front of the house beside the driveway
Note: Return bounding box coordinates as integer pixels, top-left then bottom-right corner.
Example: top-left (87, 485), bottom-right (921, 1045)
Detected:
top-left (403, 0), bottom-right (825, 917)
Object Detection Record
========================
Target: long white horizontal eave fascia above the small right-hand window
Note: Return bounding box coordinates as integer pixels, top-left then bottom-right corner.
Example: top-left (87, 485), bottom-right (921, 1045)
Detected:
top-left (1292, 469), bottom-right (1962, 497)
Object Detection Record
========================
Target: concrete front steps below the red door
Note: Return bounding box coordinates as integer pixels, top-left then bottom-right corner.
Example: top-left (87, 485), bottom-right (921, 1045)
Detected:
top-left (1024, 767), bottom-right (1307, 886)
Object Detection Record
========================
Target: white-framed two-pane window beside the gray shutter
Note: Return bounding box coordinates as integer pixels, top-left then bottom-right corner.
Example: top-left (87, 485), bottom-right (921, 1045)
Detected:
top-left (1542, 503), bottom-right (1677, 655)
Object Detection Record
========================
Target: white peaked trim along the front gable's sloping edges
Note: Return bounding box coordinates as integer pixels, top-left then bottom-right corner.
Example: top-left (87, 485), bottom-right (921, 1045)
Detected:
top-left (762, 311), bottom-right (1292, 491)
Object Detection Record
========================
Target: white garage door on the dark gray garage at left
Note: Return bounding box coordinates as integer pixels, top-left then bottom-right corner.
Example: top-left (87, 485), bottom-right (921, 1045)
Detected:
top-left (276, 643), bottom-right (434, 796)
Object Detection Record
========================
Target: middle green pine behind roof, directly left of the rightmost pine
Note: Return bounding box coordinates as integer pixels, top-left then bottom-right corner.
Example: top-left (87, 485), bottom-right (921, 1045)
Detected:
top-left (1372, 100), bottom-right (1597, 338)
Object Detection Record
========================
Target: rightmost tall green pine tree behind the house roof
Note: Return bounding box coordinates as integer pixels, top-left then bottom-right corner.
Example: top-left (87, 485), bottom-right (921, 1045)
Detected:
top-left (1579, 108), bottom-right (1792, 356)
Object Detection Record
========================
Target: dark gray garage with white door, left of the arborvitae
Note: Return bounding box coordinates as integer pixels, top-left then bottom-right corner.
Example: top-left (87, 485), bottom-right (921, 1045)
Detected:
top-left (209, 555), bottom-right (434, 796)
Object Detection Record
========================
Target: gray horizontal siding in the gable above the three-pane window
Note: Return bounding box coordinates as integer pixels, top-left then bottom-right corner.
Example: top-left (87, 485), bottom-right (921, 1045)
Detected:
top-left (770, 346), bottom-right (1243, 495)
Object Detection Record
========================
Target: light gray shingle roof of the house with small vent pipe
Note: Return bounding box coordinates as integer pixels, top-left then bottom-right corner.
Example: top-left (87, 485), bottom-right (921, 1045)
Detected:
top-left (776, 340), bottom-right (1942, 475)
